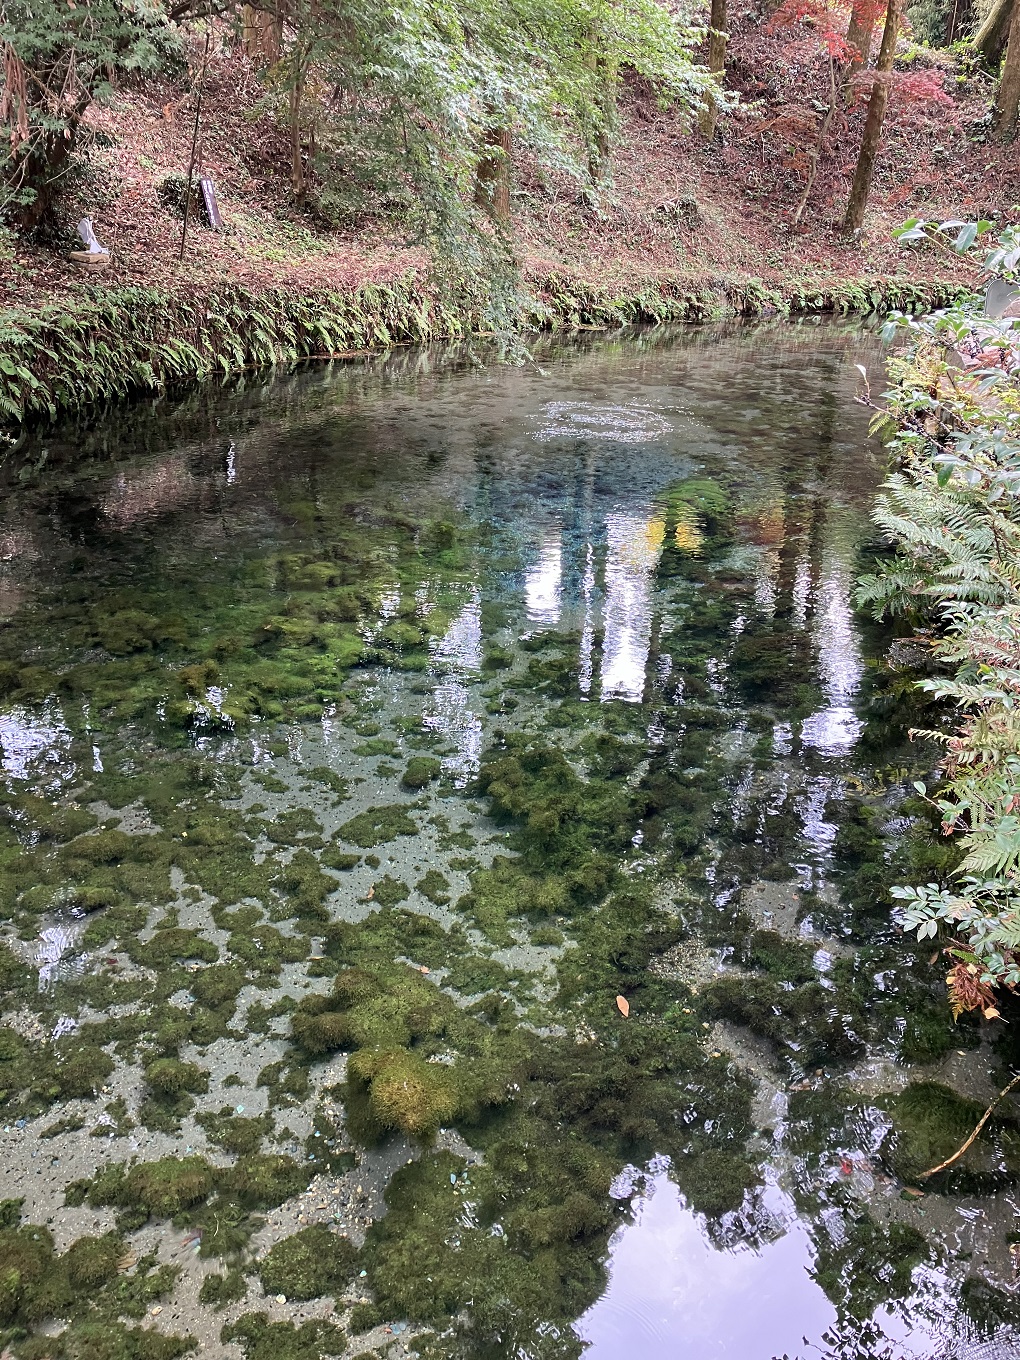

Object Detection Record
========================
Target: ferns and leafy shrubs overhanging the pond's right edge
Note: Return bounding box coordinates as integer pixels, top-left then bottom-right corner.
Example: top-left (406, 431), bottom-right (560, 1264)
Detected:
top-left (858, 222), bottom-right (1020, 1016)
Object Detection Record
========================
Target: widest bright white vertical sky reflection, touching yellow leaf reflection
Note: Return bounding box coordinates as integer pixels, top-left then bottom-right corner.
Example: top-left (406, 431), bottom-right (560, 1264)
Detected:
top-left (602, 511), bottom-right (665, 703)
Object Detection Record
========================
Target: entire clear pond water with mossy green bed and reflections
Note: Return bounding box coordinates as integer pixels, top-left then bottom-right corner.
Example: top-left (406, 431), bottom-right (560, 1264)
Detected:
top-left (0, 320), bottom-right (1020, 1360)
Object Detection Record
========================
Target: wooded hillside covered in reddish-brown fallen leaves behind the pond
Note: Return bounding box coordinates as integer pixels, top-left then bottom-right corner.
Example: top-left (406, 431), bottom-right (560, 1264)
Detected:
top-left (0, 0), bottom-right (1020, 307)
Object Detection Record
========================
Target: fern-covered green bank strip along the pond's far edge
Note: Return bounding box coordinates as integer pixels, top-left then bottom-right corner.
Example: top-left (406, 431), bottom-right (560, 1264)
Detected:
top-left (0, 273), bottom-right (959, 424)
